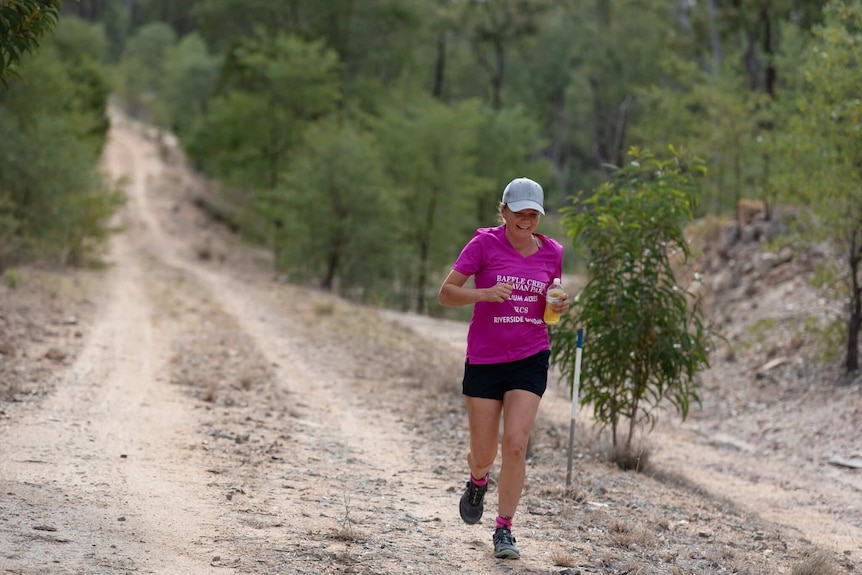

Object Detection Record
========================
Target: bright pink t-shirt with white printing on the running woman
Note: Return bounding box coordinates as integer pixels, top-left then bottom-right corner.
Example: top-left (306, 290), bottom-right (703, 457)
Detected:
top-left (452, 225), bottom-right (563, 364)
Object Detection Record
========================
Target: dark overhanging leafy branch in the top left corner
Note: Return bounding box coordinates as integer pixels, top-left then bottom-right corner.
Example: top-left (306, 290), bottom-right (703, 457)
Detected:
top-left (0, 0), bottom-right (62, 86)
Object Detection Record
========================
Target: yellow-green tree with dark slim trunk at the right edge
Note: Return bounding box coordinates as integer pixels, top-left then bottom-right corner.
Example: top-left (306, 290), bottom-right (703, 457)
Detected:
top-left (779, 0), bottom-right (862, 372)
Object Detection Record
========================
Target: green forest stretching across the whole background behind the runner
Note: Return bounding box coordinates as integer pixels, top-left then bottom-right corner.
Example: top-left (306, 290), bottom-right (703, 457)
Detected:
top-left (0, 0), bottom-right (862, 372)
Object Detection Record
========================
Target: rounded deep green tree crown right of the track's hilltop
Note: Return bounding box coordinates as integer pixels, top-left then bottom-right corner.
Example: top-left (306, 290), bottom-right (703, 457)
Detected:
top-left (187, 31), bottom-right (341, 189)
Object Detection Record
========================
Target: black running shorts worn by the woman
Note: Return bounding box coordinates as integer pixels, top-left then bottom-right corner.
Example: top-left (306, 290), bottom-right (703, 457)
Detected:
top-left (461, 350), bottom-right (551, 400)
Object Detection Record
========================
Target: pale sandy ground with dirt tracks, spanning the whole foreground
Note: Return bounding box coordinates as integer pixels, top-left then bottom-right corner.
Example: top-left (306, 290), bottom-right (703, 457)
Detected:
top-left (0, 113), bottom-right (862, 575)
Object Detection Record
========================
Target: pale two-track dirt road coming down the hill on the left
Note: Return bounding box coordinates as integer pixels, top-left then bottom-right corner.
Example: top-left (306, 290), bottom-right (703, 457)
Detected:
top-left (0, 118), bottom-right (496, 574)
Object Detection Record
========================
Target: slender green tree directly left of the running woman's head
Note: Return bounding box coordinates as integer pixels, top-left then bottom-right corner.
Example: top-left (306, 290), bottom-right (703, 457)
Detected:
top-left (373, 93), bottom-right (496, 313)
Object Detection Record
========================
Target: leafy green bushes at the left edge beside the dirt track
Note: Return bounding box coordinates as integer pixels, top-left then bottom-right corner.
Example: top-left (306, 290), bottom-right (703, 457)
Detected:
top-left (0, 32), bottom-right (122, 269)
